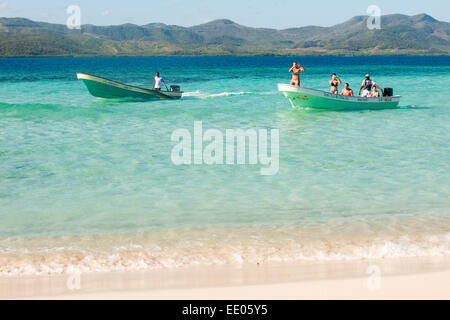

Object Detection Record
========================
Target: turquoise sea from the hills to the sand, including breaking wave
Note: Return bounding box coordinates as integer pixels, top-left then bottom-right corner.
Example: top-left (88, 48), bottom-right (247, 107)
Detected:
top-left (0, 57), bottom-right (450, 274)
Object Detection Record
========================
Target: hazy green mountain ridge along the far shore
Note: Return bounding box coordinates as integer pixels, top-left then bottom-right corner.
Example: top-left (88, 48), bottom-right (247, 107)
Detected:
top-left (0, 14), bottom-right (450, 57)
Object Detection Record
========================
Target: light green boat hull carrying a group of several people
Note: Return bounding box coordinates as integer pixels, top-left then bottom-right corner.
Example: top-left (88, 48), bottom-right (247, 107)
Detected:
top-left (278, 84), bottom-right (401, 110)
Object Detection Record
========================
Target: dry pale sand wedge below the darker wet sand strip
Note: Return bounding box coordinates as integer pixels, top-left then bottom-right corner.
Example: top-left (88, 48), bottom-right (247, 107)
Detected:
top-left (34, 271), bottom-right (450, 300)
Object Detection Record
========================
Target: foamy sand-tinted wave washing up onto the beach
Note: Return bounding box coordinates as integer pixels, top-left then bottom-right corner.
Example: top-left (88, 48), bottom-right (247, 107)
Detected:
top-left (0, 230), bottom-right (450, 276)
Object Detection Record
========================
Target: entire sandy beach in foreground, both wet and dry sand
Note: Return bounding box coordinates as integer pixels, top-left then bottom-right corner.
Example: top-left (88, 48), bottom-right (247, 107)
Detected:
top-left (0, 257), bottom-right (450, 300)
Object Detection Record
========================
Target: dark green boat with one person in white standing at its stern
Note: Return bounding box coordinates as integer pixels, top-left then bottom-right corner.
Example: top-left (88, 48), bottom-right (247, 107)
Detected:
top-left (77, 73), bottom-right (183, 100)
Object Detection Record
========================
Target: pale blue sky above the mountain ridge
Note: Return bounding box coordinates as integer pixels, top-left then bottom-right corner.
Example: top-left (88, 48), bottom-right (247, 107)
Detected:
top-left (0, 0), bottom-right (450, 29)
